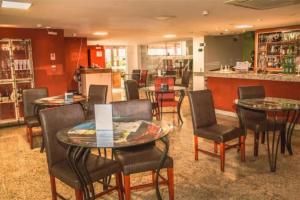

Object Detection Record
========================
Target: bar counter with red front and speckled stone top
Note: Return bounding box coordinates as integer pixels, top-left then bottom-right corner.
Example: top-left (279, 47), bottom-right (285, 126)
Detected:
top-left (205, 72), bottom-right (300, 115)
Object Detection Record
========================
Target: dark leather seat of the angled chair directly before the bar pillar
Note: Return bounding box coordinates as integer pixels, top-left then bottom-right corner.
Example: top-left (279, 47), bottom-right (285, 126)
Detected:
top-left (195, 124), bottom-right (245, 142)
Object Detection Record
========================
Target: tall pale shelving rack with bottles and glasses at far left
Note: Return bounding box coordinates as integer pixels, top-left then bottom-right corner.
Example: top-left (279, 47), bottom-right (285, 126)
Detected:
top-left (0, 39), bottom-right (34, 126)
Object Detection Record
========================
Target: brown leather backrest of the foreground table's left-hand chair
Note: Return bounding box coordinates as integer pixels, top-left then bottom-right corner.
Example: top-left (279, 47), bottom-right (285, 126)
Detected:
top-left (39, 104), bottom-right (85, 170)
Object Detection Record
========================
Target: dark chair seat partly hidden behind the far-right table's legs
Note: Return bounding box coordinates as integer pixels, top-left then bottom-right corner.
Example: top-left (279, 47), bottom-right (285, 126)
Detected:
top-left (246, 119), bottom-right (285, 132)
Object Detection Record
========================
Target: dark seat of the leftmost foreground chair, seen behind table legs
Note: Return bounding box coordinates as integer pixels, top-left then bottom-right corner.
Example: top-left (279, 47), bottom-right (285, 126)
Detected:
top-left (50, 155), bottom-right (121, 188)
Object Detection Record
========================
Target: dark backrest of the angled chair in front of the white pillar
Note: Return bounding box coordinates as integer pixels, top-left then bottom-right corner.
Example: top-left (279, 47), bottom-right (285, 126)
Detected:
top-left (189, 90), bottom-right (217, 131)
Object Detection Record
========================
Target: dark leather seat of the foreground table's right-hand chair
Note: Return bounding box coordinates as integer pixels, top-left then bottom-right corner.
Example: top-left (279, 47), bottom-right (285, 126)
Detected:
top-left (115, 145), bottom-right (173, 175)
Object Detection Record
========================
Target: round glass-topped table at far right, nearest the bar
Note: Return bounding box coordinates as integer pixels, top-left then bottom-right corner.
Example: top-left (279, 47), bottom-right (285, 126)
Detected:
top-left (237, 97), bottom-right (300, 172)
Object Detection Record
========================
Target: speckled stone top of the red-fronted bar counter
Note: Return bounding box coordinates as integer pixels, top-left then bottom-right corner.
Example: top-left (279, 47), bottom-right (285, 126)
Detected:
top-left (205, 72), bottom-right (300, 82)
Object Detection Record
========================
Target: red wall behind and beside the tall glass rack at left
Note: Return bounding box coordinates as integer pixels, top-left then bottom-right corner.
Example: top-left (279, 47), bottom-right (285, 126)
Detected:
top-left (0, 28), bottom-right (67, 95)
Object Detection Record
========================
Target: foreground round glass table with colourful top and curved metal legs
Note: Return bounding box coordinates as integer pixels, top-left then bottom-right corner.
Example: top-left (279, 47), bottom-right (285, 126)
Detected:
top-left (56, 121), bottom-right (172, 199)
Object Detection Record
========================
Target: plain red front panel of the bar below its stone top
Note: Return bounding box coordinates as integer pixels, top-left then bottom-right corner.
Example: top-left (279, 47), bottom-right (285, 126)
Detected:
top-left (207, 77), bottom-right (300, 112)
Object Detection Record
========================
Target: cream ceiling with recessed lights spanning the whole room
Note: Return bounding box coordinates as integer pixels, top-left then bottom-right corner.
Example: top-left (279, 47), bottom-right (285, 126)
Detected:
top-left (0, 0), bottom-right (300, 43)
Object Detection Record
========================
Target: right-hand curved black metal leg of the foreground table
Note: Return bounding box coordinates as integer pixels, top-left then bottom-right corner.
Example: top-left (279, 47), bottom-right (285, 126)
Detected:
top-left (155, 136), bottom-right (169, 200)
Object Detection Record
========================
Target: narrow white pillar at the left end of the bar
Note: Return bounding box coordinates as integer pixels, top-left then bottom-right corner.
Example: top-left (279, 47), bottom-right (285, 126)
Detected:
top-left (193, 36), bottom-right (205, 90)
